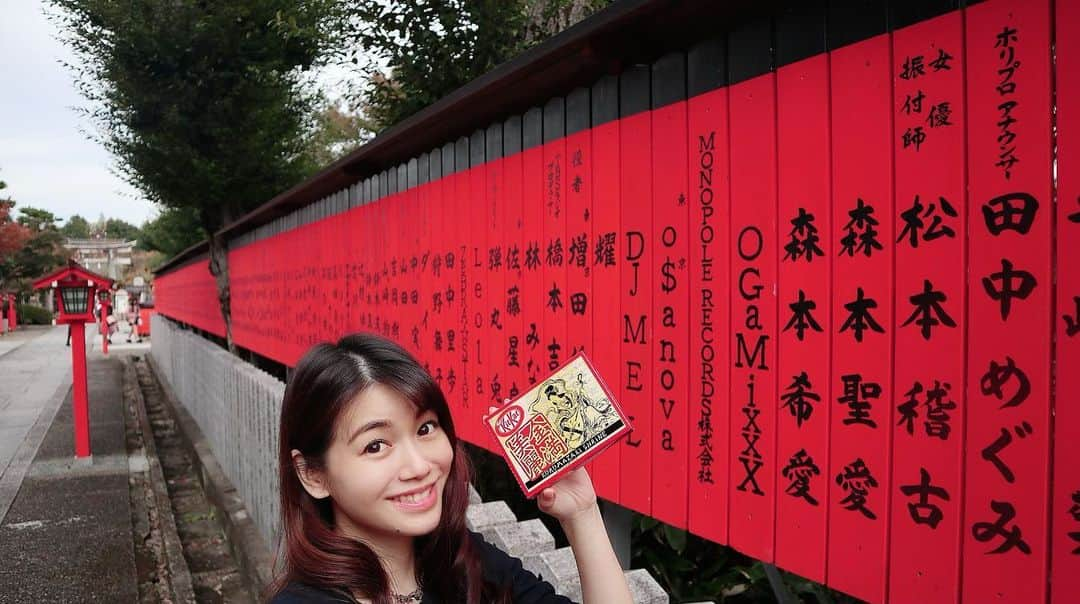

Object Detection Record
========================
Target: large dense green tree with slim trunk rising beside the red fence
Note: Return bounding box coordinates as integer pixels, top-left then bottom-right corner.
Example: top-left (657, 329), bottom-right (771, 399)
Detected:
top-left (50, 0), bottom-right (341, 346)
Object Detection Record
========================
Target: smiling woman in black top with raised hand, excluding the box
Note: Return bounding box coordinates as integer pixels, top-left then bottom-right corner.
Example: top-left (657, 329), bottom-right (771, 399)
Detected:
top-left (271, 334), bottom-right (631, 604)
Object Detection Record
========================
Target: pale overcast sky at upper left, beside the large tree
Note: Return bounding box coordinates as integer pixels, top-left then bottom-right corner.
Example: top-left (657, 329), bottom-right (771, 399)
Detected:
top-left (0, 0), bottom-right (157, 225)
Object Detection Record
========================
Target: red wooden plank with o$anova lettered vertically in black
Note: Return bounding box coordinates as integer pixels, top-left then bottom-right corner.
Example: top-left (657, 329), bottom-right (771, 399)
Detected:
top-left (649, 95), bottom-right (690, 528)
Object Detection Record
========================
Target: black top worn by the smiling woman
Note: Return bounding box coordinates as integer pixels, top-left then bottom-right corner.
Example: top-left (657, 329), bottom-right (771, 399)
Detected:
top-left (270, 531), bottom-right (572, 604)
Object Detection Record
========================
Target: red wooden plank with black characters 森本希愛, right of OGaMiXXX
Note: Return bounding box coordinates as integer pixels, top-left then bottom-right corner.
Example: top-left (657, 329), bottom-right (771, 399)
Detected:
top-left (775, 55), bottom-right (836, 581)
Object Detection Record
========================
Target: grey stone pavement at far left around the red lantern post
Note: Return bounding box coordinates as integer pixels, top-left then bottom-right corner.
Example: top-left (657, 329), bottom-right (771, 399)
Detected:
top-left (0, 326), bottom-right (138, 603)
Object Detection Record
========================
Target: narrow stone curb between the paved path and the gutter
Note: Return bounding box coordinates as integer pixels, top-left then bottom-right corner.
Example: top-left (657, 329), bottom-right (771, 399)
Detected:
top-left (123, 357), bottom-right (195, 604)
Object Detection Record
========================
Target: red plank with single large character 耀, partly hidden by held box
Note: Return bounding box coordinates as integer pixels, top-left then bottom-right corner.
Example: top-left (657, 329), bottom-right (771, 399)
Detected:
top-left (586, 121), bottom-right (624, 504)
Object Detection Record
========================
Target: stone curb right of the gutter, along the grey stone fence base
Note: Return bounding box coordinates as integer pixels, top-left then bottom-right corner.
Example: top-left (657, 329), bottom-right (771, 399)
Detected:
top-left (144, 354), bottom-right (273, 599)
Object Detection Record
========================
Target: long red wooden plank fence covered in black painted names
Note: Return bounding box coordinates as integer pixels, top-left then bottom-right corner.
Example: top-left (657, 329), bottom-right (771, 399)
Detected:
top-left (157, 0), bottom-right (1080, 603)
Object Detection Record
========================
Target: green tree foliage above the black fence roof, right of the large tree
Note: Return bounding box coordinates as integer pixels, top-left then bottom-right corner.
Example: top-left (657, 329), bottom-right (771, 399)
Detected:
top-left (342, 0), bottom-right (610, 130)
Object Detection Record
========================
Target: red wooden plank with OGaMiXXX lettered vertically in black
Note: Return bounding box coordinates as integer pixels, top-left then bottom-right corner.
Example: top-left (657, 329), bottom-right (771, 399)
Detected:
top-left (728, 73), bottom-right (778, 562)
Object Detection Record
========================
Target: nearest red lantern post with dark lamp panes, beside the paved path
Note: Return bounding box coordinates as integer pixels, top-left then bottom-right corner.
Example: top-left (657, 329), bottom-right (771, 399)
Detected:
top-left (33, 260), bottom-right (112, 457)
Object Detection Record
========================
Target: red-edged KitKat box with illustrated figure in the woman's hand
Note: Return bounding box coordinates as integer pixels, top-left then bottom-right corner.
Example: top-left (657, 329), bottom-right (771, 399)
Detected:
top-left (484, 352), bottom-right (631, 498)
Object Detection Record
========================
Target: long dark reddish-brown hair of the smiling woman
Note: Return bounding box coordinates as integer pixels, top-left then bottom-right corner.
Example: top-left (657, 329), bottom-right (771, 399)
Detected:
top-left (269, 334), bottom-right (509, 604)
